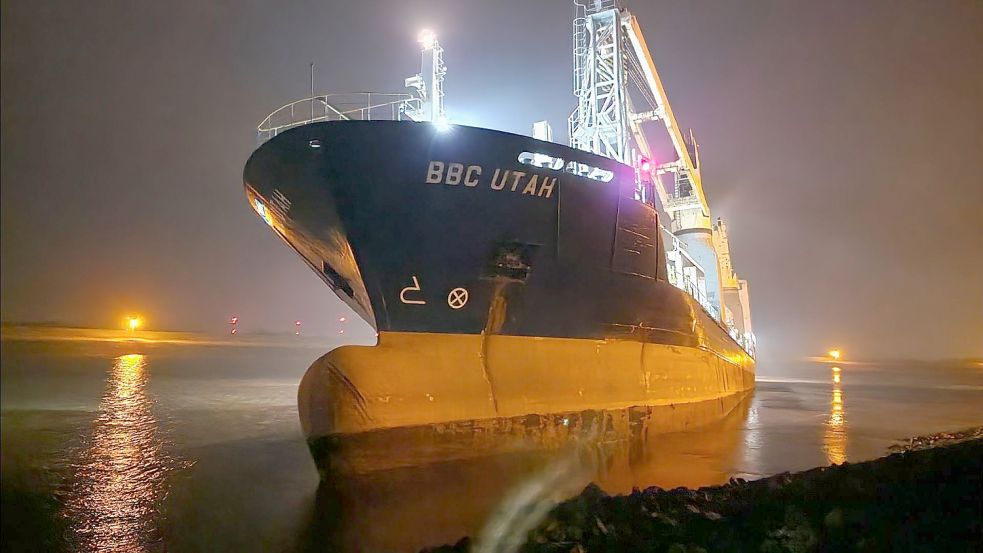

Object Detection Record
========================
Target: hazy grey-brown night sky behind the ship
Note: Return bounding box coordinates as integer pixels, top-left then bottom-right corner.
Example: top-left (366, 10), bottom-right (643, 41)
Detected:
top-left (0, 0), bottom-right (983, 359)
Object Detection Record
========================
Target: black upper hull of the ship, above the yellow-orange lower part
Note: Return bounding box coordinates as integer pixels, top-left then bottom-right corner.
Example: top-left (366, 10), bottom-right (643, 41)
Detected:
top-left (244, 121), bottom-right (753, 366)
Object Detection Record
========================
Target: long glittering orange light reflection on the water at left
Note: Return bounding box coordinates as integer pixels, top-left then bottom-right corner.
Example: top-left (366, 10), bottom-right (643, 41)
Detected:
top-left (65, 354), bottom-right (178, 551)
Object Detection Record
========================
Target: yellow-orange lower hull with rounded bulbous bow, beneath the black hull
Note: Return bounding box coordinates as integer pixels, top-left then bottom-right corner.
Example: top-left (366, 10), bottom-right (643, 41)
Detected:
top-left (298, 332), bottom-right (754, 440)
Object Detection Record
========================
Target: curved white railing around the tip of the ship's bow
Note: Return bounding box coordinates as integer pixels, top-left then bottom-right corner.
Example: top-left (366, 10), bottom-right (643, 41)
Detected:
top-left (256, 92), bottom-right (422, 141)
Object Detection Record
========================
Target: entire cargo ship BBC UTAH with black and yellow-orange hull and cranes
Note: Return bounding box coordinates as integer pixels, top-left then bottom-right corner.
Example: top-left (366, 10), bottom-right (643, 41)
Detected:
top-left (243, 2), bottom-right (754, 449)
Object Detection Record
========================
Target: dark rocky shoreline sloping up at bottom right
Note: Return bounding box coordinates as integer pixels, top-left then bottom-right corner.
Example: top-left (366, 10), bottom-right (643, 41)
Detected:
top-left (428, 427), bottom-right (983, 553)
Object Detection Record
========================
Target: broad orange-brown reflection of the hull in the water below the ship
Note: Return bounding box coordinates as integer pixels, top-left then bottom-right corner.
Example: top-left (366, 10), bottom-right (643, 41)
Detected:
top-left (308, 394), bottom-right (752, 552)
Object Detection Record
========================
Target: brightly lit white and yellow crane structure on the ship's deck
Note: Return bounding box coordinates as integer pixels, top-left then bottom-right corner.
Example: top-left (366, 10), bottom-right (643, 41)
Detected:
top-left (568, 0), bottom-right (753, 341)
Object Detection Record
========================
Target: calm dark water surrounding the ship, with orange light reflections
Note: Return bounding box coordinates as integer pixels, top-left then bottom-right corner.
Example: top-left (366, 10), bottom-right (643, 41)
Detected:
top-left (2, 332), bottom-right (983, 551)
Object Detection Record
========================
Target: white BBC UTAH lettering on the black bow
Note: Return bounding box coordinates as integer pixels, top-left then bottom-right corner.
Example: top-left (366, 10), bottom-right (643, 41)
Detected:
top-left (426, 161), bottom-right (556, 199)
